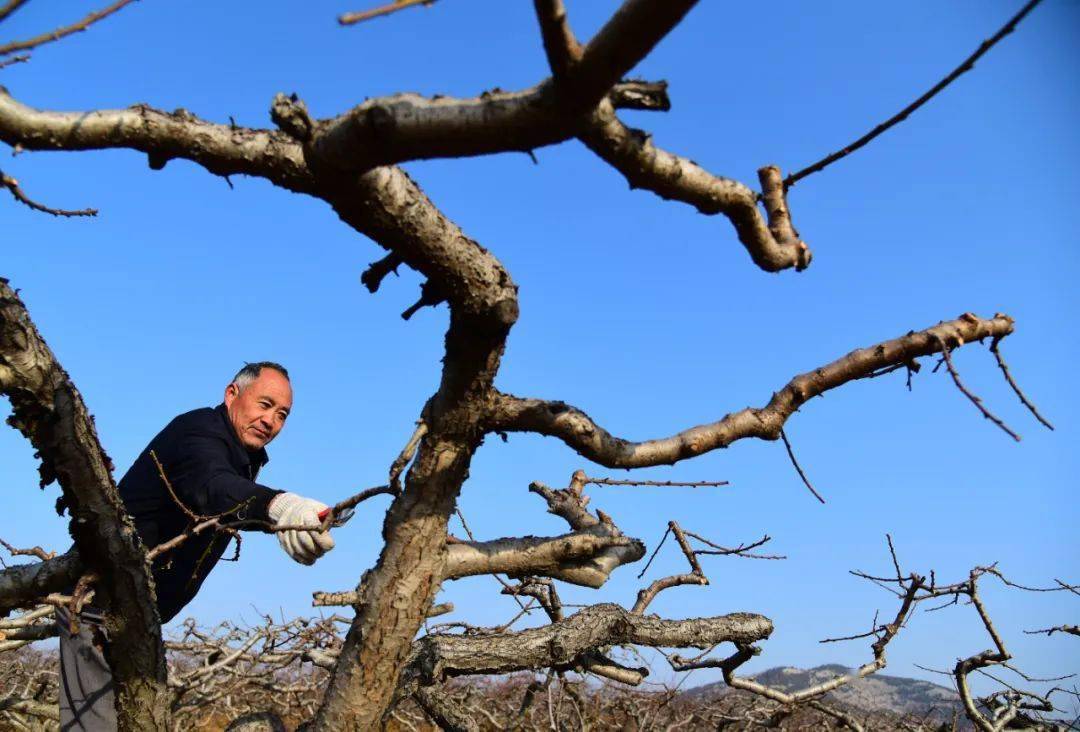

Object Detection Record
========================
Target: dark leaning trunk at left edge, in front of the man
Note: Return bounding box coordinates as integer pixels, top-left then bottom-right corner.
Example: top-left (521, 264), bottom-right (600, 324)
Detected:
top-left (0, 280), bottom-right (168, 730)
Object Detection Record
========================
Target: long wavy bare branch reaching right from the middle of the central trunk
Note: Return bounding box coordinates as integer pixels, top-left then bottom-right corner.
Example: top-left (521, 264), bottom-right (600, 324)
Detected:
top-left (487, 313), bottom-right (1013, 467)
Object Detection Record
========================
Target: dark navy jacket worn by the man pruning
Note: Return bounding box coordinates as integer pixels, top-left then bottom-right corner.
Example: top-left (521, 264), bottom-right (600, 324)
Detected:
top-left (119, 404), bottom-right (281, 623)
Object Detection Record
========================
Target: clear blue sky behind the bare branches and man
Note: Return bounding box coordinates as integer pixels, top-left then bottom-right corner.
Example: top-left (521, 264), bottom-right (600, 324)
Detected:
top-left (0, 0), bottom-right (1080, 703)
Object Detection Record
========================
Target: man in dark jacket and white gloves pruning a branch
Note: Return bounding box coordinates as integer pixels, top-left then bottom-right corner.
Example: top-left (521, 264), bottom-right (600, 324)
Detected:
top-left (57, 362), bottom-right (334, 731)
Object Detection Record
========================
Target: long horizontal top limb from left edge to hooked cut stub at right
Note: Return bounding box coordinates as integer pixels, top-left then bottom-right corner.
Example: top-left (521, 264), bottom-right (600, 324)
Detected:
top-left (0, 80), bottom-right (810, 271)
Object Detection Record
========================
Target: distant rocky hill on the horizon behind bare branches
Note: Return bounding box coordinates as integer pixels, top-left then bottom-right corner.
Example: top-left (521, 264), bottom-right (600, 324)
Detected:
top-left (686, 664), bottom-right (962, 720)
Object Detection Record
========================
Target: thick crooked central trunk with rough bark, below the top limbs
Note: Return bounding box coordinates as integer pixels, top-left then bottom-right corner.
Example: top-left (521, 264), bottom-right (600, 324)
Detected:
top-left (314, 160), bottom-right (517, 730)
